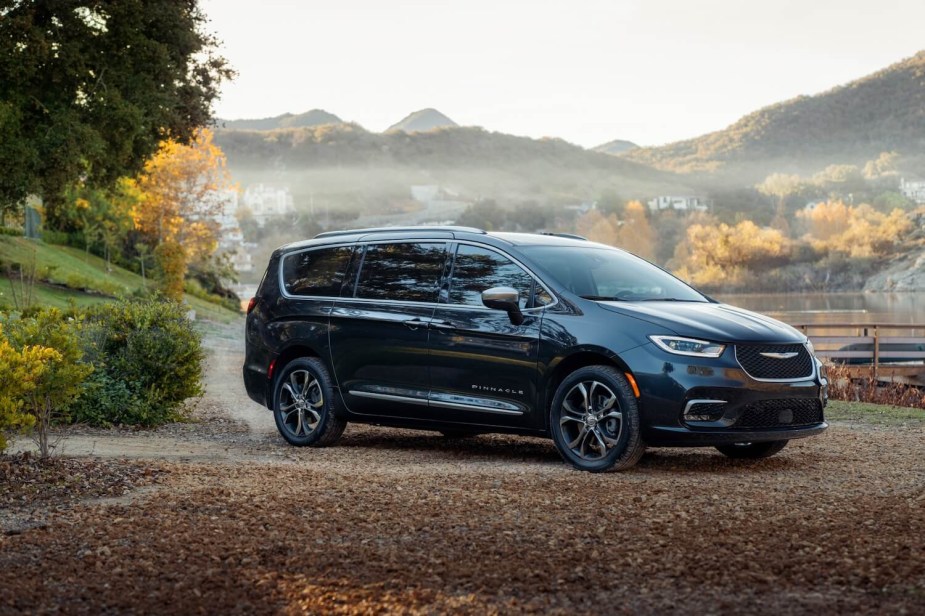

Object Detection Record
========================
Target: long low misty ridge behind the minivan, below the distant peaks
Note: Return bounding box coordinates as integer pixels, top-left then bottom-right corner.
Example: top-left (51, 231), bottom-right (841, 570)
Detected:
top-left (215, 124), bottom-right (688, 209)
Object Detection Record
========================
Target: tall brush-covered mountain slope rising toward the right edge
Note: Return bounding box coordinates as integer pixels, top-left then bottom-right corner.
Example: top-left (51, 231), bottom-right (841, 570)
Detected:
top-left (622, 51), bottom-right (925, 181)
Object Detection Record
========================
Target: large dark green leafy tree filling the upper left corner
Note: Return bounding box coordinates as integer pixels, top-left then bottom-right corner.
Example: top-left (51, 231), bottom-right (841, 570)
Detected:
top-left (0, 0), bottom-right (233, 229)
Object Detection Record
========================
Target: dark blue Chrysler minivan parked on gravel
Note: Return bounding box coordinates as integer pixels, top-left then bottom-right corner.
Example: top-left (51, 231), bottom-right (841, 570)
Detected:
top-left (244, 227), bottom-right (827, 471)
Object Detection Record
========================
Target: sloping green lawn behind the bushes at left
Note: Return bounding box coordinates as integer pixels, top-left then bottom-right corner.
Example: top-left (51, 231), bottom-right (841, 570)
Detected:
top-left (0, 235), bottom-right (240, 323)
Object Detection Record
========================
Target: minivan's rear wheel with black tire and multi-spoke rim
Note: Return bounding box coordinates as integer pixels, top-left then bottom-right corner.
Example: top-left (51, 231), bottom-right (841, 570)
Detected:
top-left (273, 357), bottom-right (347, 447)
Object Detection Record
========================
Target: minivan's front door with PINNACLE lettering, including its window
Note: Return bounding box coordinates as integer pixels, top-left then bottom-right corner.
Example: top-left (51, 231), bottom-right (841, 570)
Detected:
top-left (430, 244), bottom-right (548, 426)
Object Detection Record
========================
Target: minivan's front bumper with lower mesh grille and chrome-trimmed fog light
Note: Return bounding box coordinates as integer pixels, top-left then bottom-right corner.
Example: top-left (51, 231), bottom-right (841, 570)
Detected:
top-left (624, 345), bottom-right (828, 447)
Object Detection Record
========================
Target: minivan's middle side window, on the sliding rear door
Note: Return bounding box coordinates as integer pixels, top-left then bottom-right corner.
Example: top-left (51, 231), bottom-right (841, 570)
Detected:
top-left (356, 242), bottom-right (446, 302)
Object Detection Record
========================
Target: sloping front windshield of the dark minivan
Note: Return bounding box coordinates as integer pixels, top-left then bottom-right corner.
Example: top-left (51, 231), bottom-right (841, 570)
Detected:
top-left (521, 246), bottom-right (709, 302)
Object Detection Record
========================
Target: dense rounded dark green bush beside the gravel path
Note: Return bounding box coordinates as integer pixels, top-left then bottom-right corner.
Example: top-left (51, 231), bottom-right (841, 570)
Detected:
top-left (71, 299), bottom-right (204, 426)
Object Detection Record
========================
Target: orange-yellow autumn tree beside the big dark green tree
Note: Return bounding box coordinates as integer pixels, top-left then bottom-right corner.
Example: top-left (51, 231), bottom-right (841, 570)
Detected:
top-left (132, 129), bottom-right (232, 299)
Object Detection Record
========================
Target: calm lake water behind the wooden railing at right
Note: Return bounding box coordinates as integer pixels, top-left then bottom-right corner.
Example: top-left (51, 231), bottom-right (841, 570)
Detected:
top-left (715, 293), bottom-right (925, 325)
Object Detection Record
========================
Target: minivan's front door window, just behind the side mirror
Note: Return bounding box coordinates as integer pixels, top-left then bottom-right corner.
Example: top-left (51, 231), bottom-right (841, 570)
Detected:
top-left (449, 244), bottom-right (533, 308)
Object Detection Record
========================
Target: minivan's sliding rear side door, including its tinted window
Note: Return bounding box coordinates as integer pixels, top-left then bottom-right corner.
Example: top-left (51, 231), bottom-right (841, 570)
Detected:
top-left (330, 242), bottom-right (446, 417)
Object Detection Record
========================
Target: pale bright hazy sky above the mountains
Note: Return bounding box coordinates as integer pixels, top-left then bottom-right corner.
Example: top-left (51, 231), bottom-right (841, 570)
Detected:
top-left (200, 0), bottom-right (925, 147)
